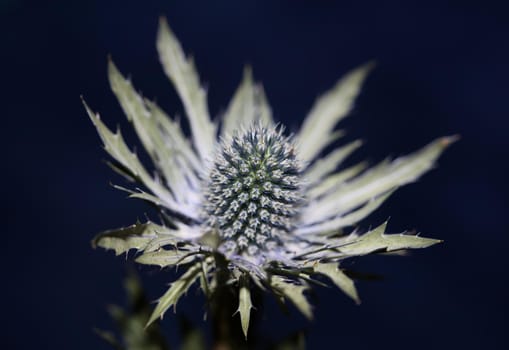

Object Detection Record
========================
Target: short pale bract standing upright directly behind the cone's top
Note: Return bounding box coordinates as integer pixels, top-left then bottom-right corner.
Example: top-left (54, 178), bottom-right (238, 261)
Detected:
top-left (221, 67), bottom-right (273, 137)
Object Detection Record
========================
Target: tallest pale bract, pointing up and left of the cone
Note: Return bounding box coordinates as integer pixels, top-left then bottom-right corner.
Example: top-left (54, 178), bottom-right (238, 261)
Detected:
top-left (157, 18), bottom-right (216, 160)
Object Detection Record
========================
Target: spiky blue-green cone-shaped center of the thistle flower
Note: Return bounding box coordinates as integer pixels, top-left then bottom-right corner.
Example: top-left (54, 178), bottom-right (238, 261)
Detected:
top-left (204, 125), bottom-right (302, 255)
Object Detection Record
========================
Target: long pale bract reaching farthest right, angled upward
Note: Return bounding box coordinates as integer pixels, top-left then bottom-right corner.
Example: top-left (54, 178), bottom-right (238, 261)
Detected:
top-left (302, 137), bottom-right (456, 224)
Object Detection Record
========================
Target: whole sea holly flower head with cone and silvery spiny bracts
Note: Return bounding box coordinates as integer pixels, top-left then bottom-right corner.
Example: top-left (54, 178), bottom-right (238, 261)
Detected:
top-left (86, 20), bottom-right (453, 335)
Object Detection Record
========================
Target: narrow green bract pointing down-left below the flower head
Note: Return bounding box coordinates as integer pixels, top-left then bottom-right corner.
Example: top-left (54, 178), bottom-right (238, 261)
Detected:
top-left (147, 262), bottom-right (202, 327)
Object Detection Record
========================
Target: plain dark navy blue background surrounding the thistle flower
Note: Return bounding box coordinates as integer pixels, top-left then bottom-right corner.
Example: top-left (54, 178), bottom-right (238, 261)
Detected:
top-left (0, 0), bottom-right (509, 349)
